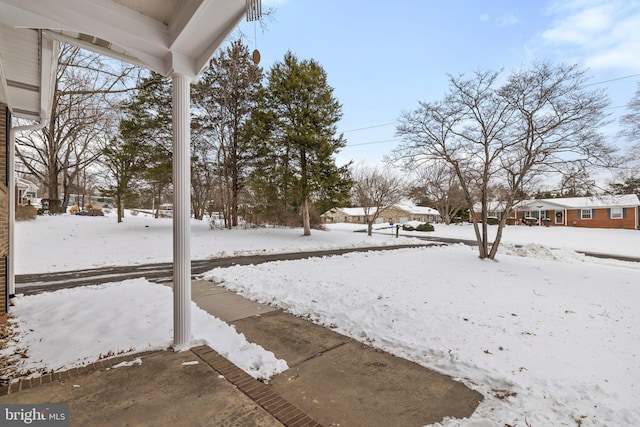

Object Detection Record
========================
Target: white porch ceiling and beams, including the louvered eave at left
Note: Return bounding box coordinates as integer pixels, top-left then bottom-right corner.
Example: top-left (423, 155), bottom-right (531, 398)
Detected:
top-left (0, 0), bottom-right (246, 120)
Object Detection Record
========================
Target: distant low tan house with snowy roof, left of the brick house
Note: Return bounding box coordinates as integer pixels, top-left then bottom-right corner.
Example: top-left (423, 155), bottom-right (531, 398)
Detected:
top-left (321, 203), bottom-right (440, 224)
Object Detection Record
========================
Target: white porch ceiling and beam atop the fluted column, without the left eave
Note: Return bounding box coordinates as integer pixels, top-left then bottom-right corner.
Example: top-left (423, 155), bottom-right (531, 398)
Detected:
top-left (0, 0), bottom-right (246, 76)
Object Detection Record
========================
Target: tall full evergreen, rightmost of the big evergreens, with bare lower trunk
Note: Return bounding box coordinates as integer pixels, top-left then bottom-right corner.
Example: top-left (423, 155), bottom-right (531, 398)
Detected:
top-left (248, 52), bottom-right (350, 236)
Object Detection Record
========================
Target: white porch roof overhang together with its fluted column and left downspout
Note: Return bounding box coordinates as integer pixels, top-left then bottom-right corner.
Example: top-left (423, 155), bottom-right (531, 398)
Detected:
top-left (0, 0), bottom-right (260, 349)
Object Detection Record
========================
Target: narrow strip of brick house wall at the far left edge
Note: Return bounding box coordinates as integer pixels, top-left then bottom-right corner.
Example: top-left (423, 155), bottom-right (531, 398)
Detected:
top-left (0, 103), bottom-right (11, 324)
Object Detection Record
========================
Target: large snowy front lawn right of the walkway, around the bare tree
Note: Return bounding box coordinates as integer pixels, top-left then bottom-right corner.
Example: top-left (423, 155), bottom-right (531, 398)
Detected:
top-left (201, 245), bottom-right (640, 426)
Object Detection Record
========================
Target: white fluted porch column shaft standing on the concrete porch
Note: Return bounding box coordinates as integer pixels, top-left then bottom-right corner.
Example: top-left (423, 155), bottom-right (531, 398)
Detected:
top-left (172, 74), bottom-right (192, 351)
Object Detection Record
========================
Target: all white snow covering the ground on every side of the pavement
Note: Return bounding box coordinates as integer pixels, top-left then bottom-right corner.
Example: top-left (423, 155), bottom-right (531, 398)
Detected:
top-left (6, 215), bottom-right (640, 426)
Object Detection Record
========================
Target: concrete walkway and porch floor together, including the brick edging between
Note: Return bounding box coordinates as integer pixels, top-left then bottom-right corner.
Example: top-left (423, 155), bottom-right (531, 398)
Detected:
top-left (0, 281), bottom-right (482, 426)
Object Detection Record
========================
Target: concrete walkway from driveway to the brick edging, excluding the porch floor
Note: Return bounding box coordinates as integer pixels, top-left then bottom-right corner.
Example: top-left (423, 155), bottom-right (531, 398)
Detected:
top-left (192, 281), bottom-right (482, 426)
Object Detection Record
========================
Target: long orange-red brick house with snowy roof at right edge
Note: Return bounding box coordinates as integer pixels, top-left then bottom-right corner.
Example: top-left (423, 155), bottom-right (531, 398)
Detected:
top-left (513, 194), bottom-right (640, 230)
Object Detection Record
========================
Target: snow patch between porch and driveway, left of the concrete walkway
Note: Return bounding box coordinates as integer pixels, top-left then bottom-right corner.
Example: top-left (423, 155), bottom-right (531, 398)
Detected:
top-left (11, 279), bottom-right (287, 378)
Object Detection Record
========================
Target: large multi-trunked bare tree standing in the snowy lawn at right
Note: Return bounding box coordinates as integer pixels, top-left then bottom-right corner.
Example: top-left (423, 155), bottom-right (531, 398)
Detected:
top-left (393, 63), bottom-right (613, 259)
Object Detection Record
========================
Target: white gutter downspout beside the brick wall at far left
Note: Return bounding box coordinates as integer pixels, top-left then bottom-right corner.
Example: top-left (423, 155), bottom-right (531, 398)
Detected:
top-left (7, 119), bottom-right (49, 305)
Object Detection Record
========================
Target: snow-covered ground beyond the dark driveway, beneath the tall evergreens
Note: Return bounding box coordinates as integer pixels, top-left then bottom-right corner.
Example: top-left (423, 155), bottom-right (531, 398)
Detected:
top-left (15, 211), bottom-right (412, 274)
